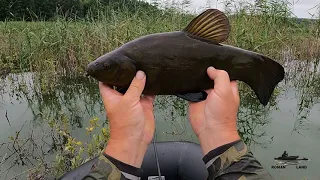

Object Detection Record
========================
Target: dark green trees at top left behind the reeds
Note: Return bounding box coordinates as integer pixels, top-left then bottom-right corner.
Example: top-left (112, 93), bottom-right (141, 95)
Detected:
top-left (0, 0), bottom-right (158, 21)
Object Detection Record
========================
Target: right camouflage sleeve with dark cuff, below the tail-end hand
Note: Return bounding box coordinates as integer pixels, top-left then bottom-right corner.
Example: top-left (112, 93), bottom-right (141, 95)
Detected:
top-left (203, 140), bottom-right (273, 180)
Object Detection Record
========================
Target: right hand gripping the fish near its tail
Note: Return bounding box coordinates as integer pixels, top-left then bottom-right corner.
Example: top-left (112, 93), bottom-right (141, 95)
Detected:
top-left (189, 67), bottom-right (240, 154)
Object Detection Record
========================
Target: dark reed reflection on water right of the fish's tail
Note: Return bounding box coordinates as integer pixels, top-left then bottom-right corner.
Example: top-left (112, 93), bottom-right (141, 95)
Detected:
top-left (285, 59), bottom-right (320, 134)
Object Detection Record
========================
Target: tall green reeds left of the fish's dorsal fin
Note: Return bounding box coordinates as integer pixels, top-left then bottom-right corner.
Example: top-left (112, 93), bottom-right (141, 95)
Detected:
top-left (0, 5), bottom-right (192, 74)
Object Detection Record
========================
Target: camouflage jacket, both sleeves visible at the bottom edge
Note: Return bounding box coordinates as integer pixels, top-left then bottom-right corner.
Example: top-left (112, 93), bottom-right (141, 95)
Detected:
top-left (83, 140), bottom-right (273, 180)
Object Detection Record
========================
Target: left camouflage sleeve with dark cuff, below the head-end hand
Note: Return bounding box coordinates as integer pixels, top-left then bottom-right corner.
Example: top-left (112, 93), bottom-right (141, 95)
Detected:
top-left (83, 153), bottom-right (142, 180)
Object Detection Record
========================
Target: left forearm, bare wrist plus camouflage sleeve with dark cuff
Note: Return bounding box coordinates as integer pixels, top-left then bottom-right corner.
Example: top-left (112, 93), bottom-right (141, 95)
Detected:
top-left (84, 139), bottom-right (148, 180)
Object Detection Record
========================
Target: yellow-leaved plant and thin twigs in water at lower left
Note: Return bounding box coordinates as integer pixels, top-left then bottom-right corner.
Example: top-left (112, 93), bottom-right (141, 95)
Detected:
top-left (0, 114), bottom-right (109, 179)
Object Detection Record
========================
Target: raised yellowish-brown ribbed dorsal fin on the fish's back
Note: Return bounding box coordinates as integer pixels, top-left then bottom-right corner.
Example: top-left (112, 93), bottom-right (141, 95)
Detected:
top-left (183, 9), bottom-right (230, 43)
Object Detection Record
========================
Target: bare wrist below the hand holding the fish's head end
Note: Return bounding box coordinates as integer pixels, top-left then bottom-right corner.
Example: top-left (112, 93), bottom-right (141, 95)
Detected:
top-left (104, 139), bottom-right (148, 168)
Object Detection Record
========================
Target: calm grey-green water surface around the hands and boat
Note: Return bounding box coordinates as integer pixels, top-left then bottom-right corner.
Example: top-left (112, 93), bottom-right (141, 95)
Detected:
top-left (0, 60), bottom-right (320, 179)
